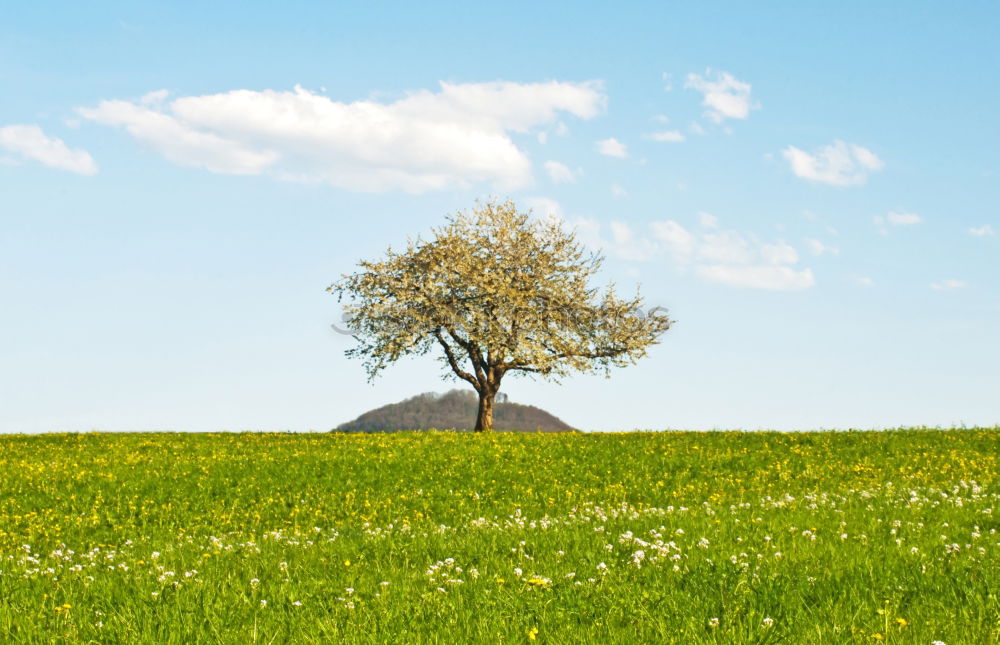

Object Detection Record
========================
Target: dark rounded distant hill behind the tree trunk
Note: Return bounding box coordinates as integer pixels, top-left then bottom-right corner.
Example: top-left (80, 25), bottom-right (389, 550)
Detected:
top-left (335, 390), bottom-right (573, 432)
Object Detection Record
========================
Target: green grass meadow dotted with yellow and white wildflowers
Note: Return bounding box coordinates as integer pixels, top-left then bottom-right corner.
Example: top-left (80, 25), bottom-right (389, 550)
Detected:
top-left (0, 428), bottom-right (1000, 645)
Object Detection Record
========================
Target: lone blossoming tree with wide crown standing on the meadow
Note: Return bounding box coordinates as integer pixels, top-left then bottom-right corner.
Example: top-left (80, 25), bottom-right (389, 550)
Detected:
top-left (327, 201), bottom-right (673, 432)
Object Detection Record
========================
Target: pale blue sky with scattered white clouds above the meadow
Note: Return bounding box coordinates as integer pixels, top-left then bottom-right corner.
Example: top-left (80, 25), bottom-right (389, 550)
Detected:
top-left (0, 2), bottom-right (1000, 432)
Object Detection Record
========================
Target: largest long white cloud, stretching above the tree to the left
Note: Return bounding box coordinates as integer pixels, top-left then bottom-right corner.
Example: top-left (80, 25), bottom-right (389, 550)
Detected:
top-left (78, 81), bottom-right (606, 193)
